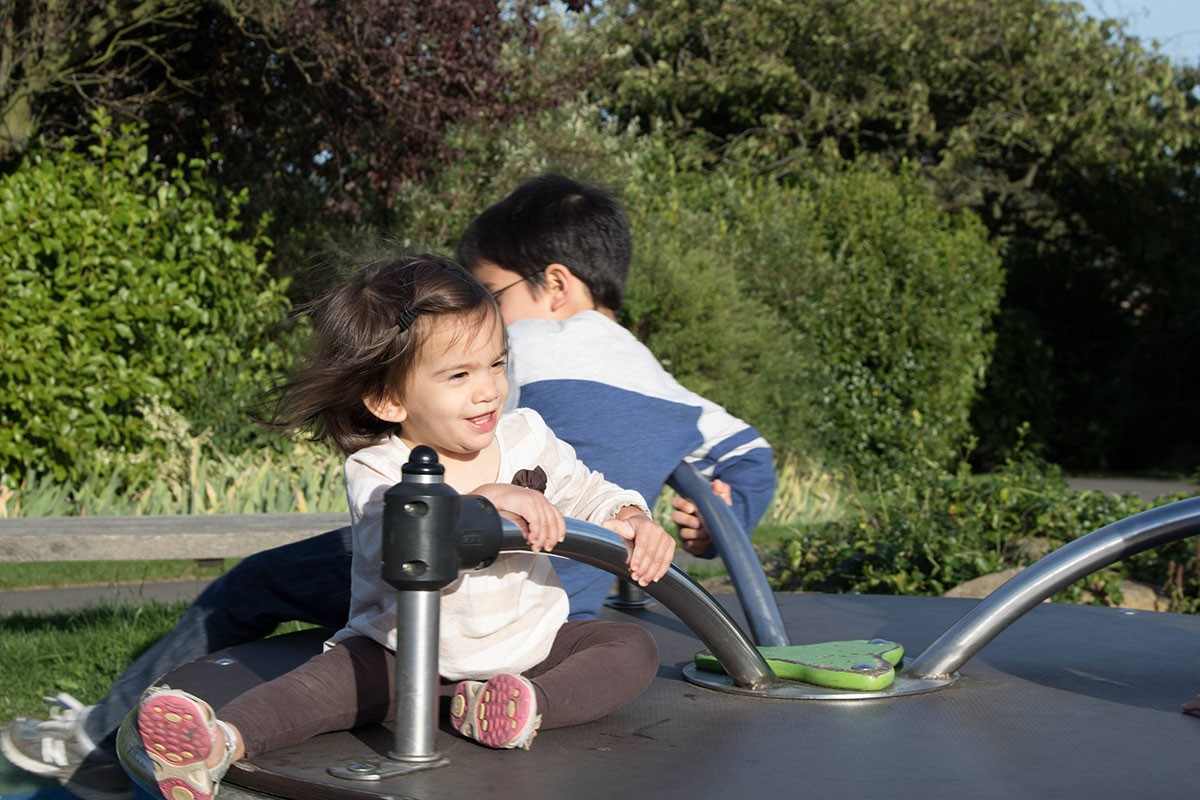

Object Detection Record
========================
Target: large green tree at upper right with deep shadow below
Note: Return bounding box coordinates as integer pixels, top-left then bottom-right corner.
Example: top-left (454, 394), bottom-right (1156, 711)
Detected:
top-left (601, 0), bottom-right (1200, 467)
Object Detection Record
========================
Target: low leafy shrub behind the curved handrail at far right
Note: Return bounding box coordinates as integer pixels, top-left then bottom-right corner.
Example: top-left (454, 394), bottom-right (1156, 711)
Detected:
top-left (762, 443), bottom-right (1200, 612)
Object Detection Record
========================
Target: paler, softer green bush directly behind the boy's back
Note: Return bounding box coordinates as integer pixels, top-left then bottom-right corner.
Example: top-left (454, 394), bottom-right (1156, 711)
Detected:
top-left (622, 159), bottom-right (815, 456)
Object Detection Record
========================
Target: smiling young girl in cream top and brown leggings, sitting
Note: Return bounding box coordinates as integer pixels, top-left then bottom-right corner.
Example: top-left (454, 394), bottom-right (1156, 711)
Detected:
top-left (138, 257), bottom-right (674, 800)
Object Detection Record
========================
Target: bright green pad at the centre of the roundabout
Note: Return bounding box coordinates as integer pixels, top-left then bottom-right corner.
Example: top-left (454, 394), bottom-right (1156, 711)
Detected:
top-left (696, 639), bottom-right (904, 692)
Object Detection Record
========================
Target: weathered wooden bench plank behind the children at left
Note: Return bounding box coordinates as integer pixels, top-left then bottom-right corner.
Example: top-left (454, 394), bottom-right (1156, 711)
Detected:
top-left (0, 512), bottom-right (350, 561)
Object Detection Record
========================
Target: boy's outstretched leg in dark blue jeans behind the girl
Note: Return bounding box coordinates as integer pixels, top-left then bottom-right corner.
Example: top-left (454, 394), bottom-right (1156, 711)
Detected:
top-left (85, 527), bottom-right (352, 758)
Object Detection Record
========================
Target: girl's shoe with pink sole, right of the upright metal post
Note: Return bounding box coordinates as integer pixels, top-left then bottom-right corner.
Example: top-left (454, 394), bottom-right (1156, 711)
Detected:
top-left (450, 674), bottom-right (541, 750)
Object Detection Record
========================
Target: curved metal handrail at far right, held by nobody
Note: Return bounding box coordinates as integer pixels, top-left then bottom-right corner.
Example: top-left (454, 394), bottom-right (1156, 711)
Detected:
top-left (905, 497), bottom-right (1200, 679)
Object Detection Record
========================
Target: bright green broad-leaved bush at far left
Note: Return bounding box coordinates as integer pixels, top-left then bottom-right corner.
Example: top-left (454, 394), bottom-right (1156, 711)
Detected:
top-left (0, 113), bottom-right (287, 479)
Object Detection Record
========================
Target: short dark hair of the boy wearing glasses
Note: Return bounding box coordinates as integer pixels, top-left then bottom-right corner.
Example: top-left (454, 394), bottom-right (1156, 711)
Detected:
top-left (457, 173), bottom-right (634, 311)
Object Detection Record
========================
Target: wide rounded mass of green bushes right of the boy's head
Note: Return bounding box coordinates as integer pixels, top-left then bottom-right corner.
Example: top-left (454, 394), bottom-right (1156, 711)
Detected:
top-left (625, 158), bottom-right (1002, 480)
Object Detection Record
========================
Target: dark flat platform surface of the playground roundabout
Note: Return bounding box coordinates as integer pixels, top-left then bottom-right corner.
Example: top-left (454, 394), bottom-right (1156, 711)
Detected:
top-left (121, 595), bottom-right (1200, 800)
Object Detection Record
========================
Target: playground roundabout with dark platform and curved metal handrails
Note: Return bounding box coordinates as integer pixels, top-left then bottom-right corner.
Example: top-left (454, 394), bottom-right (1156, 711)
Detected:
top-left (119, 462), bottom-right (1200, 800)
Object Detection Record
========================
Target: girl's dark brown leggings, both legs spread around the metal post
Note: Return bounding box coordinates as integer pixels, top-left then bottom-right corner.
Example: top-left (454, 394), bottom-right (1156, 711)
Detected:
top-left (217, 621), bottom-right (659, 757)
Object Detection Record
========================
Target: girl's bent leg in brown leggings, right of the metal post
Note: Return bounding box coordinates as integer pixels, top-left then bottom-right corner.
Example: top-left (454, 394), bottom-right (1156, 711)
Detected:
top-left (524, 621), bottom-right (659, 730)
